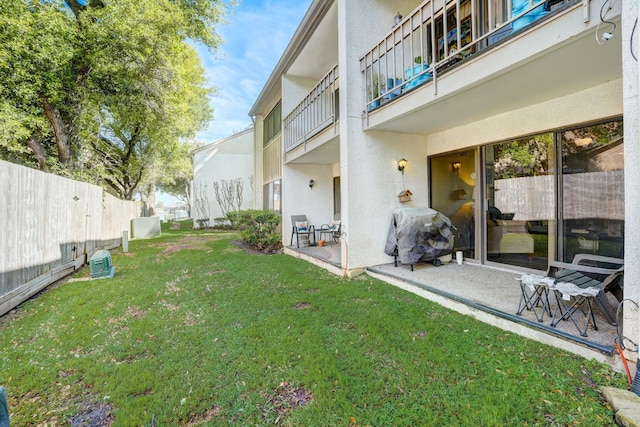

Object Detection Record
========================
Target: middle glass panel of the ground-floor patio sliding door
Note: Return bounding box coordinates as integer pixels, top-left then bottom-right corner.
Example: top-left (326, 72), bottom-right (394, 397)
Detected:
top-left (484, 133), bottom-right (555, 270)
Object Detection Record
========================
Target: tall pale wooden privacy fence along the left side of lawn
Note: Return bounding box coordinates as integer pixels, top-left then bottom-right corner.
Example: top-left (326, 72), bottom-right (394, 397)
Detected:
top-left (0, 161), bottom-right (140, 316)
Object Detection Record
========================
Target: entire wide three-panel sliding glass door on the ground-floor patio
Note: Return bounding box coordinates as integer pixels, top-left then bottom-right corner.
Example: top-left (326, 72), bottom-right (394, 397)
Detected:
top-left (430, 120), bottom-right (624, 271)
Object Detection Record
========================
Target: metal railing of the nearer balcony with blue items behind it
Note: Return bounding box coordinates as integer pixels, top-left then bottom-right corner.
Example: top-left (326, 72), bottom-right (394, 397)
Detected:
top-left (360, 0), bottom-right (580, 111)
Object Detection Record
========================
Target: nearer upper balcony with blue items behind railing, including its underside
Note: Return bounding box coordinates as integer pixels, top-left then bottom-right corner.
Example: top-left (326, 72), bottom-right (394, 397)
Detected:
top-left (360, 0), bottom-right (621, 133)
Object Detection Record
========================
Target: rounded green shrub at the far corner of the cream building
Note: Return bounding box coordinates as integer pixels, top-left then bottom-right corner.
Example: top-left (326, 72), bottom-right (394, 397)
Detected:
top-left (227, 209), bottom-right (282, 252)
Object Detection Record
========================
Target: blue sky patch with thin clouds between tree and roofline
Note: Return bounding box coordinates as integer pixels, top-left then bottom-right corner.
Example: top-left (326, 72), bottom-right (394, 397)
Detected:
top-left (196, 0), bottom-right (311, 144)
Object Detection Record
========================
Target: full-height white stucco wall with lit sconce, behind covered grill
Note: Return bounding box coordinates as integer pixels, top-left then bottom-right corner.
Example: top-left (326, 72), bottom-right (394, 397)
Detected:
top-left (338, 0), bottom-right (429, 269)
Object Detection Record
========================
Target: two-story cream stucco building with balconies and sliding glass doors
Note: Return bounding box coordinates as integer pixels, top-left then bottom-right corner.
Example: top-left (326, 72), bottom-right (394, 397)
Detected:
top-left (250, 0), bottom-right (640, 364)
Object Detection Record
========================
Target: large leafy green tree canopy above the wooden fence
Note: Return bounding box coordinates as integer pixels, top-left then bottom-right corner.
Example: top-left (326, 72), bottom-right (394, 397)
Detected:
top-left (0, 0), bottom-right (229, 199)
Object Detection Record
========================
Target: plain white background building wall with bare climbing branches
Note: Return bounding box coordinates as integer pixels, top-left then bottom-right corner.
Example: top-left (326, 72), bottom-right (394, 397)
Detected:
top-left (191, 128), bottom-right (254, 228)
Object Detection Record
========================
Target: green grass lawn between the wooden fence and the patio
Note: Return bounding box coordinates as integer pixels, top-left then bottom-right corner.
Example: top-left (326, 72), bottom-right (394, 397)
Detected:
top-left (0, 224), bottom-right (626, 427)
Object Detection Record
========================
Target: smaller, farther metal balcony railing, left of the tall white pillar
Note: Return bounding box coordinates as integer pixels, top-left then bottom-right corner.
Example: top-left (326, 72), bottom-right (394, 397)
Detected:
top-left (283, 64), bottom-right (339, 152)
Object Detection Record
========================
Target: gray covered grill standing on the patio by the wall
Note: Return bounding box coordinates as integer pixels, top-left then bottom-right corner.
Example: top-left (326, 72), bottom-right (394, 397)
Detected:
top-left (384, 208), bottom-right (453, 264)
